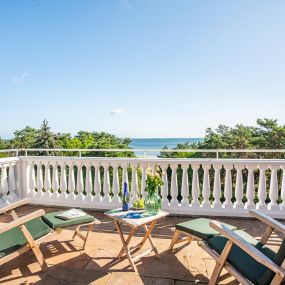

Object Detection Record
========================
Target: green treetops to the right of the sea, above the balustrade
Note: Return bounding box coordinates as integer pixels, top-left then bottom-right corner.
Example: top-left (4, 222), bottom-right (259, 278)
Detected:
top-left (160, 119), bottom-right (285, 158)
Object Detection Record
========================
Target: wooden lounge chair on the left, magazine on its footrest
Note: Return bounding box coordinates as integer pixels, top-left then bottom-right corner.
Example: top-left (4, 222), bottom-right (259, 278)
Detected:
top-left (0, 199), bottom-right (100, 271)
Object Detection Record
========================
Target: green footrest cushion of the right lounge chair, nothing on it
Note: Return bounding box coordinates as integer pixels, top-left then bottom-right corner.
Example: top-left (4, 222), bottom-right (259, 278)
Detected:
top-left (175, 218), bottom-right (237, 240)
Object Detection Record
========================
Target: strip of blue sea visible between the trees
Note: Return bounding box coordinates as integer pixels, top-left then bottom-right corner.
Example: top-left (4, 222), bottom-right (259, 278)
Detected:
top-left (129, 138), bottom-right (203, 156)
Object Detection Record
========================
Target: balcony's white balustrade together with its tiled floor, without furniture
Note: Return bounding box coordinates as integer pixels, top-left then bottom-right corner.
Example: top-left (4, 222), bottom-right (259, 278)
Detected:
top-left (0, 150), bottom-right (285, 285)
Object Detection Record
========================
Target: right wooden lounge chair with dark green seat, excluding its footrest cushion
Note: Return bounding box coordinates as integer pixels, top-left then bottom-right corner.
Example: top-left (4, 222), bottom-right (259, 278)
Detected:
top-left (170, 210), bottom-right (285, 285)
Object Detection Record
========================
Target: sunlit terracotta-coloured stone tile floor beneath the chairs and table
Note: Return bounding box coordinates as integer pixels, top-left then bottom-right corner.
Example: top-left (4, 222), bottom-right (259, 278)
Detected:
top-left (0, 206), bottom-right (281, 285)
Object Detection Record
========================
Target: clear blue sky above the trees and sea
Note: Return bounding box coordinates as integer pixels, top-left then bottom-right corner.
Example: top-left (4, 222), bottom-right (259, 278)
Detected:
top-left (0, 0), bottom-right (285, 137)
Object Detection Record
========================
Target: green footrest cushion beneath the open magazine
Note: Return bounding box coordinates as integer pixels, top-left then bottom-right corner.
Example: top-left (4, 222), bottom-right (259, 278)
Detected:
top-left (42, 209), bottom-right (95, 229)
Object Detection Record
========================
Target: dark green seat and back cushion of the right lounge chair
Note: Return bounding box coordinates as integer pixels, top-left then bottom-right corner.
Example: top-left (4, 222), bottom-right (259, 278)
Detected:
top-left (208, 230), bottom-right (276, 285)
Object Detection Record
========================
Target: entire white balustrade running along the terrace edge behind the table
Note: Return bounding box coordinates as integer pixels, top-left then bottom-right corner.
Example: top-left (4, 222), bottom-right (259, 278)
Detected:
top-left (0, 156), bottom-right (285, 218)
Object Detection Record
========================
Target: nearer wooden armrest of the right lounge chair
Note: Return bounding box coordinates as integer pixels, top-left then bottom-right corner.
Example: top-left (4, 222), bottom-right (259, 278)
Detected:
top-left (210, 221), bottom-right (285, 276)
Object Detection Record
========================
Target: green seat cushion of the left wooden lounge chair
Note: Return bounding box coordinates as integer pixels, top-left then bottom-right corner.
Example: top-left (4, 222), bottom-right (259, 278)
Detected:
top-left (0, 218), bottom-right (51, 258)
